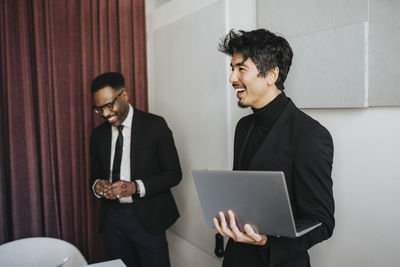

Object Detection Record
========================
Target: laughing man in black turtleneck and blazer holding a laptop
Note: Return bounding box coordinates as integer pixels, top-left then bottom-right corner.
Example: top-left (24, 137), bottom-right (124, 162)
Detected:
top-left (214, 29), bottom-right (335, 267)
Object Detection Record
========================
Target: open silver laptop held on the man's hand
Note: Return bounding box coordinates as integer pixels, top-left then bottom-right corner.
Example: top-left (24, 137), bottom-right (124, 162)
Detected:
top-left (192, 170), bottom-right (321, 238)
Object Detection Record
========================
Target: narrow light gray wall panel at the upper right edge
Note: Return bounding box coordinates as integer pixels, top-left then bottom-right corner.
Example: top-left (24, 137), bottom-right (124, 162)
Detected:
top-left (369, 0), bottom-right (400, 106)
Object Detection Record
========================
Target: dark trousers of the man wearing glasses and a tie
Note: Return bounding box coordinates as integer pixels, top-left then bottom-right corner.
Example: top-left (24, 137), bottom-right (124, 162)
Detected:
top-left (103, 205), bottom-right (170, 267)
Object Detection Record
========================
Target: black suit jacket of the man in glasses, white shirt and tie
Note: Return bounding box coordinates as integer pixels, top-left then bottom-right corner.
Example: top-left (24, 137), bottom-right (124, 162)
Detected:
top-left (90, 108), bottom-right (182, 233)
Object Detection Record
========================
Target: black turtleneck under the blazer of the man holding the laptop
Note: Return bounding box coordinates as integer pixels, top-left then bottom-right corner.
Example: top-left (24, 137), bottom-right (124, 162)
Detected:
top-left (242, 92), bottom-right (289, 169)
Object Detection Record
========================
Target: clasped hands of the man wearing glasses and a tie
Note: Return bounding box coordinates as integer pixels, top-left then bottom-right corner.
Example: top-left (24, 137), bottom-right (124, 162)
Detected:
top-left (95, 180), bottom-right (136, 199)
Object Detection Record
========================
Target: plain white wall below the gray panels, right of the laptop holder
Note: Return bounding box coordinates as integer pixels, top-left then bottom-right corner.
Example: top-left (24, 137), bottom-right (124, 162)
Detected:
top-left (305, 107), bottom-right (400, 267)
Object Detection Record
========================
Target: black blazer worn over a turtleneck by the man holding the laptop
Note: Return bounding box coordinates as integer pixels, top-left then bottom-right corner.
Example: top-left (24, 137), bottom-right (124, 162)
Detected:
top-left (225, 100), bottom-right (335, 267)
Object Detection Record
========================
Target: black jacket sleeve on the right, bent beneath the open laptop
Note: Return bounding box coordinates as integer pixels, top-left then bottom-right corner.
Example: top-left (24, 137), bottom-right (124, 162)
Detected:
top-left (265, 125), bottom-right (335, 266)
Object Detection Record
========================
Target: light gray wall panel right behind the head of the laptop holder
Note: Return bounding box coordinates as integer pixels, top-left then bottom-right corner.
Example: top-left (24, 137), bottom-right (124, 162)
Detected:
top-left (285, 22), bottom-right (368, 108)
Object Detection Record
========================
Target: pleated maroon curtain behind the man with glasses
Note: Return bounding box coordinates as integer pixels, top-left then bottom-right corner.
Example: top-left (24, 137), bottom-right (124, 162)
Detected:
top-left (0, 0), bottom-right (147, 262)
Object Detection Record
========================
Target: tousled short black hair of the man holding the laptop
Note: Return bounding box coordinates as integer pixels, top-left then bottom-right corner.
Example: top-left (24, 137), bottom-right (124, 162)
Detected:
top-left (218, 29), bottom-right (293, 90)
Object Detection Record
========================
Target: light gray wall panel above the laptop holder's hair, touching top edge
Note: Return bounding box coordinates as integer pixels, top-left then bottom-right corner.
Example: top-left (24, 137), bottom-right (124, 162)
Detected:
top-left (257, 0), bottom-right (368, 38)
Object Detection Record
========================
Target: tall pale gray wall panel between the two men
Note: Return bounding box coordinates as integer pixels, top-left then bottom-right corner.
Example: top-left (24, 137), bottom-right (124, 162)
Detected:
top-left (152, 1), bottom-right (230, 260)
